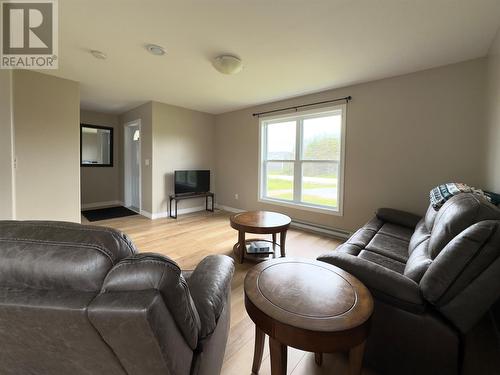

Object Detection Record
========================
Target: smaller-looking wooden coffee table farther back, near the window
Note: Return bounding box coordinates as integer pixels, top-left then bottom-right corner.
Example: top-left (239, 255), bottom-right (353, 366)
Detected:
top-left (229, 211), bottom-right (292, 263)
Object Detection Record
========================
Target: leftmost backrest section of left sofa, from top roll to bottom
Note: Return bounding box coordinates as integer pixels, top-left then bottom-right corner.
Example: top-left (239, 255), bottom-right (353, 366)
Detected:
top-left (0, 221), bottom-right (139, 375)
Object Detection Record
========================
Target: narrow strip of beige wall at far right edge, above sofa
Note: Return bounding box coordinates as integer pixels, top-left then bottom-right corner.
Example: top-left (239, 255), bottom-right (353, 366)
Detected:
top-left (487, 30), bottom-right (500, 192)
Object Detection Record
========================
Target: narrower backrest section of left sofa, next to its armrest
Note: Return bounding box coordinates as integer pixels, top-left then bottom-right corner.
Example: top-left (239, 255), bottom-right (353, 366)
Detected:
top-left (88, 253), bottom-right (201, 375)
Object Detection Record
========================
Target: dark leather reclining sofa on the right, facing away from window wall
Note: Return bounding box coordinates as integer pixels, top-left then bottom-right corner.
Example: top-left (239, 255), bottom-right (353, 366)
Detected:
top-left (318, 194), bottom-right (500, 375)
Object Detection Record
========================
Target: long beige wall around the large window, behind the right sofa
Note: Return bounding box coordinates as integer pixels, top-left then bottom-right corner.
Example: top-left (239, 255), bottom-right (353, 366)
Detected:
top-left (215, 58), bottom-right (488, 230)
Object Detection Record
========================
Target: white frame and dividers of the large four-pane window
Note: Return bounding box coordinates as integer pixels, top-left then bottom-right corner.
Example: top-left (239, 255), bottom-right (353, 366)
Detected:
top-left (257, 104), bottom-right (347, 216)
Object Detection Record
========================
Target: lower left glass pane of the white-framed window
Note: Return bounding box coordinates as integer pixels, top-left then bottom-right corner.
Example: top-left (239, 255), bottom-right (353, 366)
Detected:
top-left (266, 162), bottom-right (293, 201)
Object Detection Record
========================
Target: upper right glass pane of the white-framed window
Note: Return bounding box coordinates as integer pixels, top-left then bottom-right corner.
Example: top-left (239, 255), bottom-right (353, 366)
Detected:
top-left (302, 113), bottom-right (342, 160)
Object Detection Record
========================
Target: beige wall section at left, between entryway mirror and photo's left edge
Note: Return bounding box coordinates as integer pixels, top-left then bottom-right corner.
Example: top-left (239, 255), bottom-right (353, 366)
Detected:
top-left (13, 70), bottom-right (80, 222)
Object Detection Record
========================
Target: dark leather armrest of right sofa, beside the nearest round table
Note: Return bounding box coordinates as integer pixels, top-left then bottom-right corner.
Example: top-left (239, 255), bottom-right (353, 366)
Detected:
top-left (318, 251), bottom-right (425, 312)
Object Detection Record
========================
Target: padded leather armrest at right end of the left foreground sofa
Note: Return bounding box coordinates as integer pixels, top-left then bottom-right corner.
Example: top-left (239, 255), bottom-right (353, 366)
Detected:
top-left (188, 255), bottom-right (234, 339)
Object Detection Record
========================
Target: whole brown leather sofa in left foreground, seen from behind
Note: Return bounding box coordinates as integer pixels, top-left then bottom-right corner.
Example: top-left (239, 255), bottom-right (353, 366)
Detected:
top-left (0, 221), bottom-right (234, 375)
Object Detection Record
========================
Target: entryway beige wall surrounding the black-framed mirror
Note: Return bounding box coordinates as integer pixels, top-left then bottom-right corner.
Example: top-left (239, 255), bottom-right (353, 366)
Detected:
top-left (80, 110), bottom-right (123, 207)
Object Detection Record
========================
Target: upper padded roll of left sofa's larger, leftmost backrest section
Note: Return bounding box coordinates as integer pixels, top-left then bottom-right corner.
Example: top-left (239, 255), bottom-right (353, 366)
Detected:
top-left (0, 221), bottom-right (136, 292)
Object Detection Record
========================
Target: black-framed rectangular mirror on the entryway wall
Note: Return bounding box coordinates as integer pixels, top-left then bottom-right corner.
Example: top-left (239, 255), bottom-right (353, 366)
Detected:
top-left (80, 124), bottom-right (113, 167)
